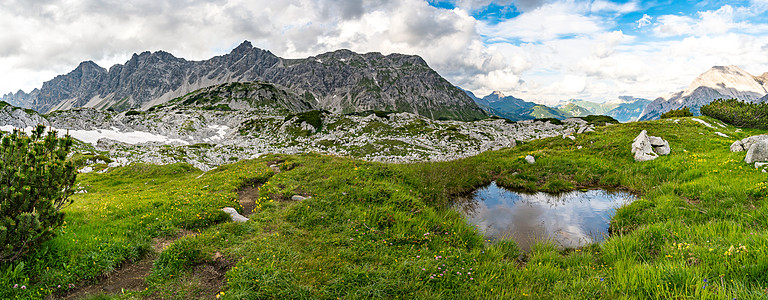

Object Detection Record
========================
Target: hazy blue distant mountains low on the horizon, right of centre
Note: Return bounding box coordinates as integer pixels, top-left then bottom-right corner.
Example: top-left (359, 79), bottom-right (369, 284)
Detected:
top-left (464, 90), bottom-right (651, 122)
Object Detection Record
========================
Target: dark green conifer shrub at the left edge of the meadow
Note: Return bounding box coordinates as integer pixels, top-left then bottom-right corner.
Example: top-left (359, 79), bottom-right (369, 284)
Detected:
top-left (0, 125), bottom-right (77, 262)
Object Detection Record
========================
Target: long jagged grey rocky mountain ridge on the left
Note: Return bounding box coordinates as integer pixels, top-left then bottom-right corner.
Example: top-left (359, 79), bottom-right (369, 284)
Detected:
top-left (0, 41), bottom-right (487, 120)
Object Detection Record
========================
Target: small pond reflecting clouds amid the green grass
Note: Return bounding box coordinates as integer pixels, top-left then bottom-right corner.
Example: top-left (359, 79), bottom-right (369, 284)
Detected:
top-left (456, 182), bottom-right (637, 251)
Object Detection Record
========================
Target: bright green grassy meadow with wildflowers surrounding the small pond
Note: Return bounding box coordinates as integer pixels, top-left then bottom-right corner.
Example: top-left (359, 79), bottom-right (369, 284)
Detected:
top-left (0, 117), bottom-right (768, 299)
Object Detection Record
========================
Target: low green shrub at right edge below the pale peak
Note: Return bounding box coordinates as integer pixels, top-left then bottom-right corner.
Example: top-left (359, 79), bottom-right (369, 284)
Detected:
top-left (701, 99), bottom-right (768, 129)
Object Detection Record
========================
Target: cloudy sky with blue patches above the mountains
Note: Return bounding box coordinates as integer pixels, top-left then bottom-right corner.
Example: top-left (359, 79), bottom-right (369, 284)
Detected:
top-left (0, 0), bottom-right (768, 104)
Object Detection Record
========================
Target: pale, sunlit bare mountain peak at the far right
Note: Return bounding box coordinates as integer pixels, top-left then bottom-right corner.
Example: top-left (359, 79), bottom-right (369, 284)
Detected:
top-left (639, 66), bottom-right (768, 120)
